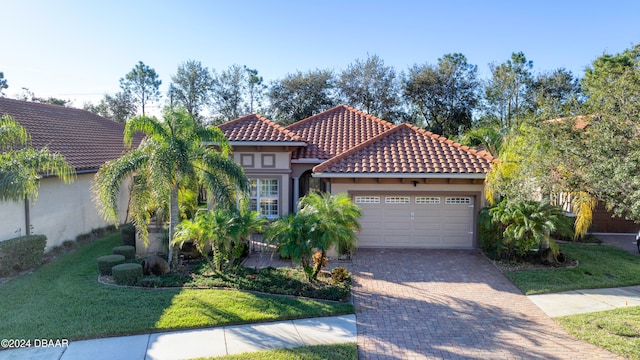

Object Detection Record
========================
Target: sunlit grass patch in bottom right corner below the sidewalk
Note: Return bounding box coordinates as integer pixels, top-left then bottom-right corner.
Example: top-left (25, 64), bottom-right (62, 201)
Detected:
top-left (554, 306), bottom-right (640, 360)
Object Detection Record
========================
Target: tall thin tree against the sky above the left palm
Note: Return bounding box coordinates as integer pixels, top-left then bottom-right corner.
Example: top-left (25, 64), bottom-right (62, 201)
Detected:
top-left (120, 61), bottom-right (162, 116)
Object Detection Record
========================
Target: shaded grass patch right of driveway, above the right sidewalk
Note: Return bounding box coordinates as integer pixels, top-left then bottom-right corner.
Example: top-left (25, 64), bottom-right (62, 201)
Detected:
top-left (505, 244), bottom-right (640, 295)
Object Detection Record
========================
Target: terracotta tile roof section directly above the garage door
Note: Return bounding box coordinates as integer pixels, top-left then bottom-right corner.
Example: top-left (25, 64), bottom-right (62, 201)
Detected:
top-left (313, 124), bottom-right (493, 174)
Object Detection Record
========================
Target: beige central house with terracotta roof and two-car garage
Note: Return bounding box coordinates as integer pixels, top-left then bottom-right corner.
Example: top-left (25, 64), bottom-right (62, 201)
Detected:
top-left (220, 105), bottom-right (493, 249)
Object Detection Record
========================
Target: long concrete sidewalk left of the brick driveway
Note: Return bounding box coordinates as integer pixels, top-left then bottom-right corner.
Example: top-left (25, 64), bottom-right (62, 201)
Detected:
top-left (0, 315), bottom-right (357, 360)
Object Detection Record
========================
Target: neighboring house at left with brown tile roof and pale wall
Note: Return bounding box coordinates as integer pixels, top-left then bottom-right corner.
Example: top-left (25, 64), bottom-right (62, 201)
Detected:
top-left (0, 98), bottom-right (135, 248)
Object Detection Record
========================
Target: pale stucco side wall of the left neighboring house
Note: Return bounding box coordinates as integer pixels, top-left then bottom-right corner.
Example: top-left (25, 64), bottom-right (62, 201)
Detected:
top-left (0, 173), bottom-right (129, 249)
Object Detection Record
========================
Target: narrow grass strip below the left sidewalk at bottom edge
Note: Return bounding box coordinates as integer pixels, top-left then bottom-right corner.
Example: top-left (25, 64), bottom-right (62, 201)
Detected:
top-left (199, 343), bottom-right (358, 360)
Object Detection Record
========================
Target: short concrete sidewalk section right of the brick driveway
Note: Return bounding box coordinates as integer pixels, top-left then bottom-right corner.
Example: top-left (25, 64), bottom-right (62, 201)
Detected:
top-left (527, 286), bottom-right (640, 317)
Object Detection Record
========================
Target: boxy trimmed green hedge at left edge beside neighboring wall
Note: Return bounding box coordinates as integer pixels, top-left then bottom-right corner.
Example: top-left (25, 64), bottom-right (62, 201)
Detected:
top-left (0, 235), bottom-right (47, 275)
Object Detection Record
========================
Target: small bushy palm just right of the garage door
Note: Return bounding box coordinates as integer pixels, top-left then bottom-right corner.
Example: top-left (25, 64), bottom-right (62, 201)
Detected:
top-left (490, 199), bottom-right (573, 261)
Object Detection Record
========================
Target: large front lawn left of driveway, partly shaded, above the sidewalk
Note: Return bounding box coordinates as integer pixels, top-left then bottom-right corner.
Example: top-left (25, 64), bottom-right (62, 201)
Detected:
top-left (0, 233), bottom-right (354, 340)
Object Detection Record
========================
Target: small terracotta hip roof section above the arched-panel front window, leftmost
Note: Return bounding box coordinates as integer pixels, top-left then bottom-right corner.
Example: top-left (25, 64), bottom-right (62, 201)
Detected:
top-left (218, 114), bottom-right (303, 142)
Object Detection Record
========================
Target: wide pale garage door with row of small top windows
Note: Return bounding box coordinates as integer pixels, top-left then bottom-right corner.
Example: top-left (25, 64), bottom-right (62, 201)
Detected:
top-left (353, 194), bottom-right (474, 249)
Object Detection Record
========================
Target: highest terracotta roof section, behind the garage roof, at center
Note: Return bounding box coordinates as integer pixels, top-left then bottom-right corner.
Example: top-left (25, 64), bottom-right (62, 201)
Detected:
top-left (286, 105), bottom-right (395, 159)
